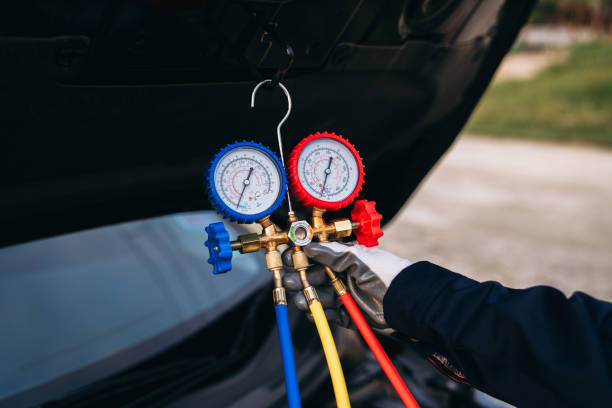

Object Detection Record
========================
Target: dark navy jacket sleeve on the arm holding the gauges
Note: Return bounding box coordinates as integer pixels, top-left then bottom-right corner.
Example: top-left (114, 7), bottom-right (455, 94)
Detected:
top-left (383, 262), bottom-right (612, 407)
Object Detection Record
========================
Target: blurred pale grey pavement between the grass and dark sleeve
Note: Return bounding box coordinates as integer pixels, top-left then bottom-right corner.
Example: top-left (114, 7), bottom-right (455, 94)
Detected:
top-left (381, 135), bottom-right (612, 301)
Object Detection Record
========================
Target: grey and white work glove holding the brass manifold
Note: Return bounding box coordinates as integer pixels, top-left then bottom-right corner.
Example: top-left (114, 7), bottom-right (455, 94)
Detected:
top-left (283, 242), bottom-right (410, 329)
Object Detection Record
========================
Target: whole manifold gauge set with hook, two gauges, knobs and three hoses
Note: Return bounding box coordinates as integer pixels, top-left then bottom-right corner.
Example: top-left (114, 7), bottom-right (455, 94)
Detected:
top-left (205, 80), bottom-right (418, 408)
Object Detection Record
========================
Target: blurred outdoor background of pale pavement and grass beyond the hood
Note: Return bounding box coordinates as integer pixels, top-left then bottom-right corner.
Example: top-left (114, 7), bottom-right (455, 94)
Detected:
top-left (381, 0), bottom-right (612, 301)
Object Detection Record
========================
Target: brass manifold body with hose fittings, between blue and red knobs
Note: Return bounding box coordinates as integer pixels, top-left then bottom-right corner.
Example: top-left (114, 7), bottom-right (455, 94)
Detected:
top-left (230, 208), bottom-right (359, 305)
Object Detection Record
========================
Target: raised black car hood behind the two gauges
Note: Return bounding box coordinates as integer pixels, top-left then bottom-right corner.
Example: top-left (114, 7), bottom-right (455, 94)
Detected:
top-left (0, 0), bottom-right (534, 245)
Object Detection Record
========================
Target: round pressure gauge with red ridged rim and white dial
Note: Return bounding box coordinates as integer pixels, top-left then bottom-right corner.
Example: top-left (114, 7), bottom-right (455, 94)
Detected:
top-left (287, 132), bottom-right (365, 211)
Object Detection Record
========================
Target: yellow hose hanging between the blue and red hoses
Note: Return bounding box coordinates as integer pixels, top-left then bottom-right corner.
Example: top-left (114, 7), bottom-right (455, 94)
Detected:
top-left (310, 301), bottom-right (351, 408)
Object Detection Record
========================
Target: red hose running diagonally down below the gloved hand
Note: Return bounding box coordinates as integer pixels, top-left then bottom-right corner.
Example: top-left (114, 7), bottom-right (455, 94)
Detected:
top-left (340, 292), bottom-right (419, 408)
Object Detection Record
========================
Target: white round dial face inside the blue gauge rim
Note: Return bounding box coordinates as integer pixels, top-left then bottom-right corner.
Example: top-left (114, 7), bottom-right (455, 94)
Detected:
top-left (213, 146), bottom-right (283, 215)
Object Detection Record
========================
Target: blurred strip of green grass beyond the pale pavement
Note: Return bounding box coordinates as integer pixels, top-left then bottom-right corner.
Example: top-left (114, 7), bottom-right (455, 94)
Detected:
top-left (466, 42), bottom-right (612, 147)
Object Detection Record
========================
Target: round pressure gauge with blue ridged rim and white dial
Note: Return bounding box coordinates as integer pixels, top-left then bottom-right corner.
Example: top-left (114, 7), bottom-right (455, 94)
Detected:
top-left (206, 141), bottom-right (287, 224)
